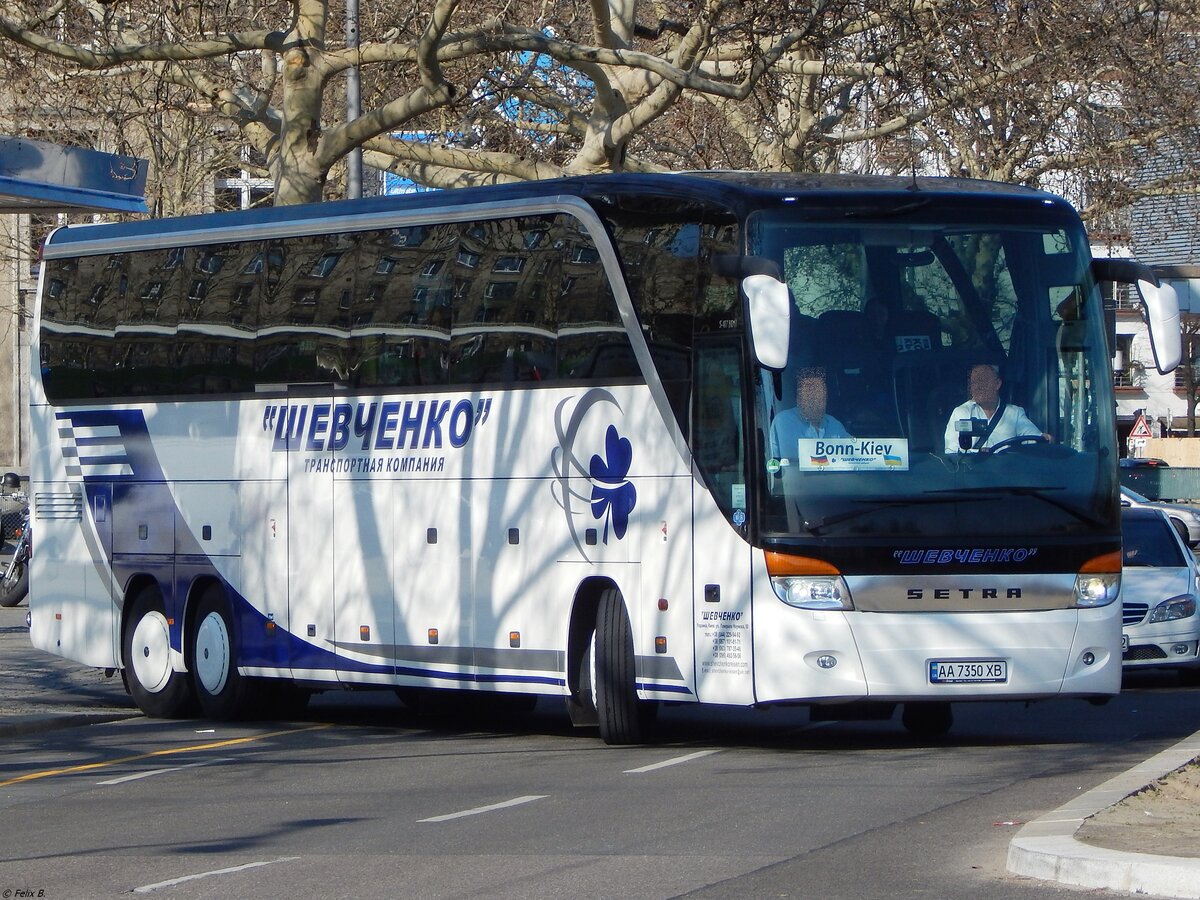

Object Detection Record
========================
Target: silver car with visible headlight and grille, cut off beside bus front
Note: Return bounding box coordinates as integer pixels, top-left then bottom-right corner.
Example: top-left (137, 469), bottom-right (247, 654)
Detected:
top-left (1121, 506), bottom-right (1200, 684)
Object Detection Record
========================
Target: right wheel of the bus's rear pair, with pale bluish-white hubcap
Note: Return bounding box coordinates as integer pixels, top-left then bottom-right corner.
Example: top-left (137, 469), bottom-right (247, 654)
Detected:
top-left (187, 584), bottom-right (263, 721)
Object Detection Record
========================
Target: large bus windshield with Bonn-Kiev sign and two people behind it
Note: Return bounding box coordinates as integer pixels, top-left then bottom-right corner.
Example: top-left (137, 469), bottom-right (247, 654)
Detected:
top-left (748, 204), bottom-right (1117, 541)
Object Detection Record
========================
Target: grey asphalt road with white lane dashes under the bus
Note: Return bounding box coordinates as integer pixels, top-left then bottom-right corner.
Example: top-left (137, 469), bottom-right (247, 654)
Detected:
top-left (0, 613), bottom-right (1200, 898)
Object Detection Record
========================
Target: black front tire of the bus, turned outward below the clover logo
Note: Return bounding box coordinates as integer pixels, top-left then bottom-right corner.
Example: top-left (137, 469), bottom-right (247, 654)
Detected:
top-left (592, 588), bottom-right (654, 744)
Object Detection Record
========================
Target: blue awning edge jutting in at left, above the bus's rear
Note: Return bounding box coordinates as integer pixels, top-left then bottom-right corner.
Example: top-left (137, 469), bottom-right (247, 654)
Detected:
top-left (0, 137), bottom-right (148, 212)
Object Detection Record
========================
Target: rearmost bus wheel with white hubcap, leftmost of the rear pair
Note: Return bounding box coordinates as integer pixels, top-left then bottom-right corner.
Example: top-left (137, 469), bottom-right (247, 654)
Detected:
top-left (121, 587), bottom-right (194, 719)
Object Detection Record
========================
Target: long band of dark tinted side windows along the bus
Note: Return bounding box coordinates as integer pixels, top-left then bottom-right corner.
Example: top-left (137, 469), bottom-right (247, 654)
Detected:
top-left (41, 210), bottom-right (643, 400)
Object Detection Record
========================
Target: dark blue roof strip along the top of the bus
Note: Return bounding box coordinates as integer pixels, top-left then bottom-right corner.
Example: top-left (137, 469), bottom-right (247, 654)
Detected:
top-left (39, 170), bottom-right (1069, 257)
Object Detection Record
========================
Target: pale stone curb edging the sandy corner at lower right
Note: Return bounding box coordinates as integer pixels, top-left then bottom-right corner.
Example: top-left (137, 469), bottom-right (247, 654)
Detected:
top-left (1008, 731), bottom-right (1200, 900)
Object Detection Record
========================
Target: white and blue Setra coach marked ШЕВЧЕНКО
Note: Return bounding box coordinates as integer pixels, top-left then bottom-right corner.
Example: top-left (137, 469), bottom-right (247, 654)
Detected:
top-left (30, 173), bottom-right (1180, 744)
